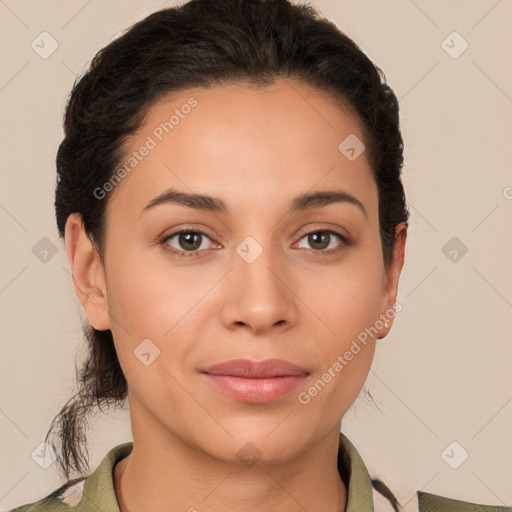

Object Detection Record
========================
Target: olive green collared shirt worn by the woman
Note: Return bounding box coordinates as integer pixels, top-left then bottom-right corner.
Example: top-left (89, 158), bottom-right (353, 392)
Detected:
top-left (10, 433), bottom-right (512, 512)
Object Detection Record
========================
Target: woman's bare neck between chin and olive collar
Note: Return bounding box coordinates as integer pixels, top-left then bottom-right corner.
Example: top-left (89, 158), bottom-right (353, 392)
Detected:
top-left (114, 412), bottom-right (347, 512)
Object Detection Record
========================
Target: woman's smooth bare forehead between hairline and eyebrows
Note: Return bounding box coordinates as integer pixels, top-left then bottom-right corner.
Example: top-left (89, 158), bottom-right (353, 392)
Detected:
top-left (105, 79), bottom-right (377, 219)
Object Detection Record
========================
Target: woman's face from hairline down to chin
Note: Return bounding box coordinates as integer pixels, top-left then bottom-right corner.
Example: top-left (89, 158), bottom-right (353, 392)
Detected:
top-left (68, 80), bottom-right (405, 461)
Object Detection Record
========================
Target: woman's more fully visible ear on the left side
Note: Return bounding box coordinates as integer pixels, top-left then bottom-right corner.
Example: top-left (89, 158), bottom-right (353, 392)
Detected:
top-left (64, 213), bottom-right (110, 331)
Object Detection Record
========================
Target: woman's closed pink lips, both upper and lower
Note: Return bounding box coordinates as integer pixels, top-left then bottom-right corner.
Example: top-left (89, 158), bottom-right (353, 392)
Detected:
top-left (202, 359), bottom-right (309, 403)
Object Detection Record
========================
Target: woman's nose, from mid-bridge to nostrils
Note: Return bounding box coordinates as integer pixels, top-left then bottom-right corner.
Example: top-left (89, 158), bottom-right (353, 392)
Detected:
top-left (222, 241), bottom-right (298, 334)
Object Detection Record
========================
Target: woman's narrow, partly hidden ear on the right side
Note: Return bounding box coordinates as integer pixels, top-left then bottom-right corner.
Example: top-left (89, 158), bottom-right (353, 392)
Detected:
top-left (377, 222), bottom-right (407, 339)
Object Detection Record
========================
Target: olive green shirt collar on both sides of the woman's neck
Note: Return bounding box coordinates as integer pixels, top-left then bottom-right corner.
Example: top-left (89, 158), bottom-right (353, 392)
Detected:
top-left (76, 432), bottom-right (374, 512)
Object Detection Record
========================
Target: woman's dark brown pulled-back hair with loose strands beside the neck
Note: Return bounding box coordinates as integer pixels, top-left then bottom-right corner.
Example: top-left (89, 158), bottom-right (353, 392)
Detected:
top-left (46, 0), bottom-right (409, 510)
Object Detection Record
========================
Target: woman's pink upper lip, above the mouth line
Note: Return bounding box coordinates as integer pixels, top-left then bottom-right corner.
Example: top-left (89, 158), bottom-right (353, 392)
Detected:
top-left (204, 359), bottom-right (309, 379)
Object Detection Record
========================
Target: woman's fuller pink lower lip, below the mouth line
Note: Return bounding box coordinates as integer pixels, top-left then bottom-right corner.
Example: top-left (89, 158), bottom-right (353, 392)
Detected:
top-left (203, 373), bottom-right (307, 403)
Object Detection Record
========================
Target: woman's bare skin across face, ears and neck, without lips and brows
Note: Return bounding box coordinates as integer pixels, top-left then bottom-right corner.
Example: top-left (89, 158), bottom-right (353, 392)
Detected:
top-left (65, 79), bottom-right (406, 512)
